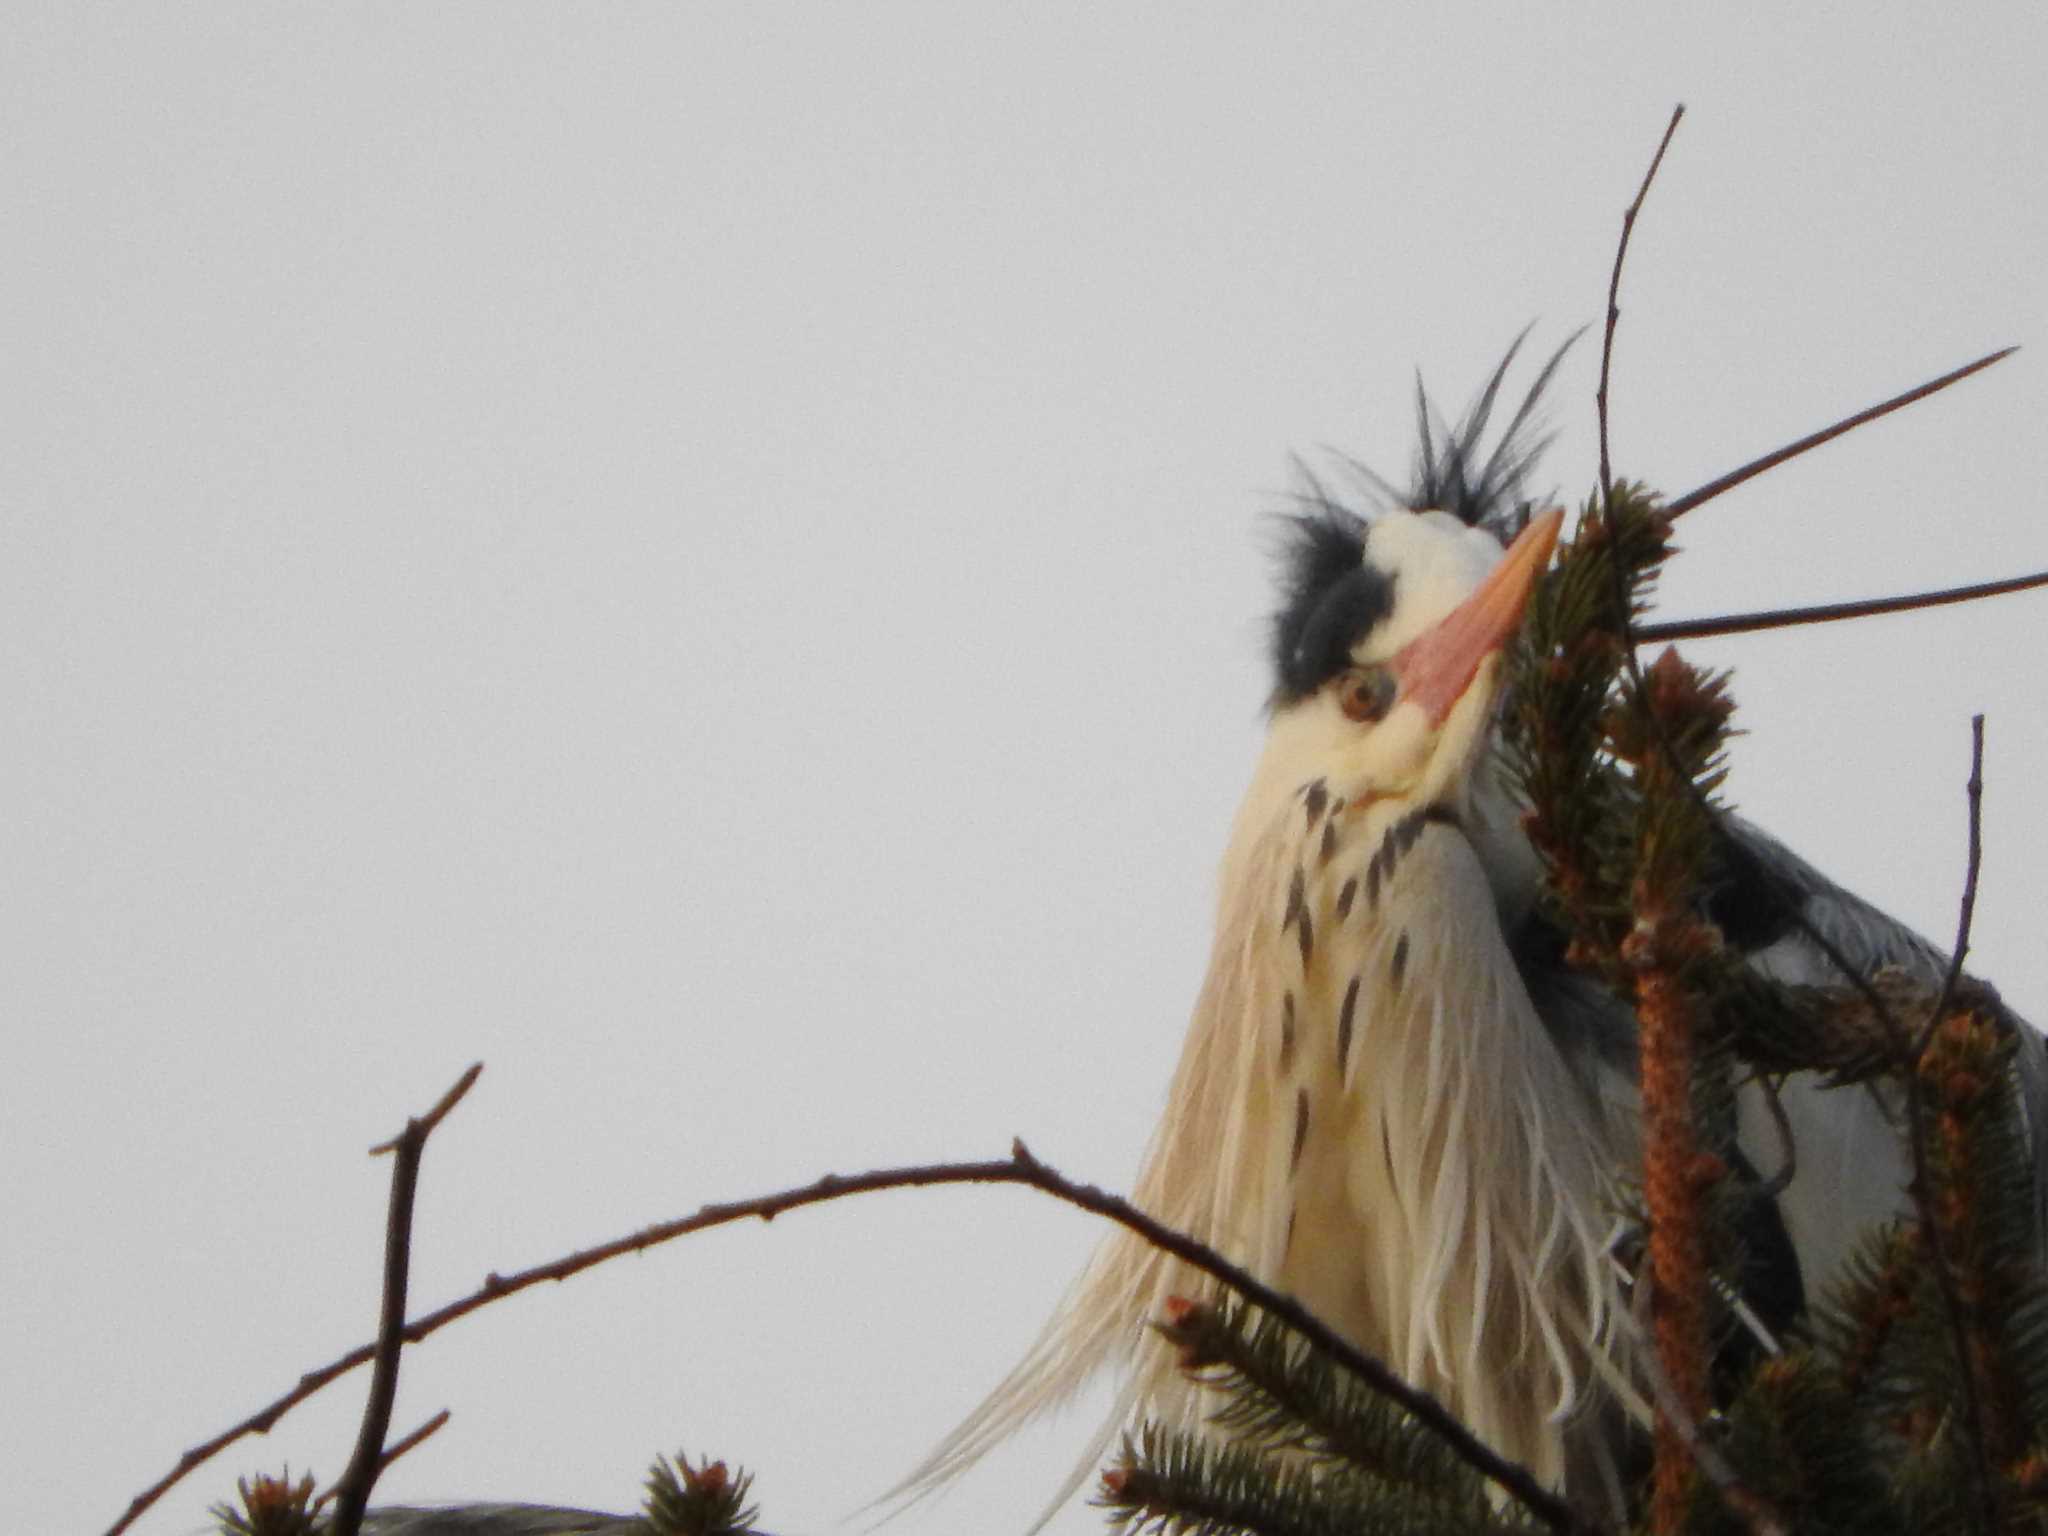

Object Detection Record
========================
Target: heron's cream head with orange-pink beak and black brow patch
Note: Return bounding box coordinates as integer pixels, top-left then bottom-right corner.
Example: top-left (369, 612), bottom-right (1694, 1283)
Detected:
top-left (1274, 508), bottom-right (1565, 807)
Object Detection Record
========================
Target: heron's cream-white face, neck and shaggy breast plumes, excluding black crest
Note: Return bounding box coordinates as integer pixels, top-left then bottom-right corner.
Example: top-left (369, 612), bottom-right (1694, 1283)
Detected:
top-left (1122, 512), bottom-right (1628, 1477)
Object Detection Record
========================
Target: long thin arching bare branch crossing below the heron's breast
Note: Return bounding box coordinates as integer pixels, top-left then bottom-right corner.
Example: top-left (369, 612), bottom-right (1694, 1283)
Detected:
top-left (106, 1143), bottom-right (1597, 1536)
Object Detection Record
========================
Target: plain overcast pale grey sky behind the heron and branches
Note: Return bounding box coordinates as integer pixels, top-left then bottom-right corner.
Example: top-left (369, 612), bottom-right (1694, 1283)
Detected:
top-left (0, 12), bottom-right (2048, 1534)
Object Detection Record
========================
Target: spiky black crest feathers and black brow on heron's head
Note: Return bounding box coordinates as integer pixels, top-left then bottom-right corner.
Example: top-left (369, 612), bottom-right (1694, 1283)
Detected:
top-left (1274, 330), bottom-right (1581, 705)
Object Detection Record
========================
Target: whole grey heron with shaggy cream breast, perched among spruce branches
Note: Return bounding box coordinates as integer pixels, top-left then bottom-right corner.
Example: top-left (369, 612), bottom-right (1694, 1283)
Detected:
top-left (905, 352), bottom-right (2044, 1501)
